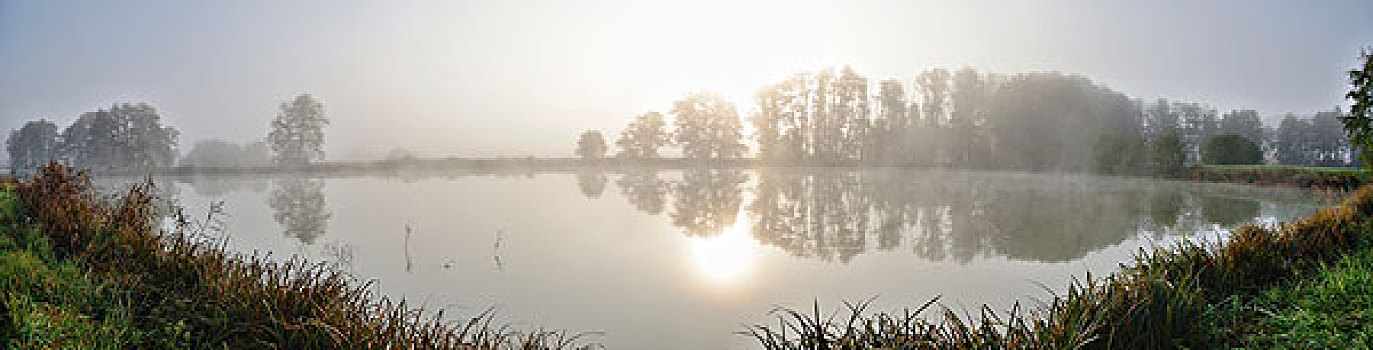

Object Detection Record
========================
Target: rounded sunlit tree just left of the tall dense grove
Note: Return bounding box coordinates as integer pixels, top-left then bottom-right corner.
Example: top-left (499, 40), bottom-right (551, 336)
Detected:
top-left (673, 92), bottom-right (747, 158)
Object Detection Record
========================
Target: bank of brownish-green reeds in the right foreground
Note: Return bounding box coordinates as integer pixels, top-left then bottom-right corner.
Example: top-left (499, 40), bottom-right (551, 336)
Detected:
top-left (748, 181), bottom-right (1373, 349)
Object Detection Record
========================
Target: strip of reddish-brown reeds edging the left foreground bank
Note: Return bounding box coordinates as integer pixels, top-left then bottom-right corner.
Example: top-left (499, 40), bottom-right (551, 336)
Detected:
top-left (7, 163), bottom-right (589, 349)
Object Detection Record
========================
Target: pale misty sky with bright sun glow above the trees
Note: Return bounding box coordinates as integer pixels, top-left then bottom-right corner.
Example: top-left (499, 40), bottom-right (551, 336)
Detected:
top-left (0, 0), bottom-right (1373, 159)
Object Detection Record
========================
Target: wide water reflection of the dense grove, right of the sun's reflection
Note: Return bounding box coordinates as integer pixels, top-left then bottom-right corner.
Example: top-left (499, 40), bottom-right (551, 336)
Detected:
top-left (748, 170), bottom-right (1285, 262)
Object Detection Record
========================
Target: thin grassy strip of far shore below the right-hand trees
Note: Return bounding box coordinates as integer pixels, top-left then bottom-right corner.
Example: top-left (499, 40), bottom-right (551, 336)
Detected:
top-left (1182, 165), bottom-right (1373, 189)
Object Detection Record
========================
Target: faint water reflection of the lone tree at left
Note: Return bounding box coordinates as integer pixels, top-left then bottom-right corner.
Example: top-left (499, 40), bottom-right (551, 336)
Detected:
top-left (268, 178), bottom-right (331, 244)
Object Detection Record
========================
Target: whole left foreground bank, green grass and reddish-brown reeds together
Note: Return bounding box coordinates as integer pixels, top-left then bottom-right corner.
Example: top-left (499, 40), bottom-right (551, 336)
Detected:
top-left (0, 166), bottom-right (590, 349)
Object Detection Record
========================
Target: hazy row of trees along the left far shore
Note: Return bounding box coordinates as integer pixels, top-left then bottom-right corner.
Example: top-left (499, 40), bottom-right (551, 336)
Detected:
top-left (5, 95), bottom-right (328, 173)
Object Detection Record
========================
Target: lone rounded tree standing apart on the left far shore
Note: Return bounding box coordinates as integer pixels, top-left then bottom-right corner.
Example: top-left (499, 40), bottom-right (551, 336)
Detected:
top-left (266, 93), bottom-right (330, 166)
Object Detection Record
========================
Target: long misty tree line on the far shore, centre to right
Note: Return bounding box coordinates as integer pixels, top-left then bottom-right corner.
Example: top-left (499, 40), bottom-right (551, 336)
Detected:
top-left (577, 67), bottom-right (1354, 174)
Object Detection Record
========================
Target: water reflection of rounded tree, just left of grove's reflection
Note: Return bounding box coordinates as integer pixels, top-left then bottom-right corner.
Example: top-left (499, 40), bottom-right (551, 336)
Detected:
top-left (671, 169), bottom-right (748, 236)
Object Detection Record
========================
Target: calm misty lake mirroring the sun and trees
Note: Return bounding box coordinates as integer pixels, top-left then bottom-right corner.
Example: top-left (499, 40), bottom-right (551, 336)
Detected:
top-left (142, 169), bottom-right (1322, 349)
